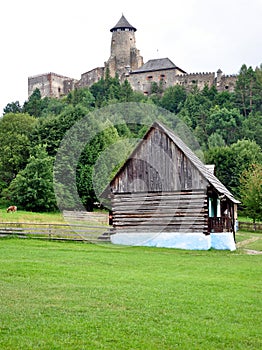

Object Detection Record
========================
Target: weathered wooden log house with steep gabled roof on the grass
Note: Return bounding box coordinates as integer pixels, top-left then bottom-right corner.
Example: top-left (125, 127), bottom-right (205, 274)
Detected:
top-left (103, 122), bottom-right (239, 249)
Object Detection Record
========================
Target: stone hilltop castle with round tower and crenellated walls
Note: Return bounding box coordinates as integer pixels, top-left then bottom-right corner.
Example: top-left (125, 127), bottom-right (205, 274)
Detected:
top-left (28, 15), bottom-right (237, 98)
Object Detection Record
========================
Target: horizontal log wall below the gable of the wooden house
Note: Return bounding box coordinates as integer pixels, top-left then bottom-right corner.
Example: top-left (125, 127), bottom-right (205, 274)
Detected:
top-left (112, 190), bottom-right (208, 234)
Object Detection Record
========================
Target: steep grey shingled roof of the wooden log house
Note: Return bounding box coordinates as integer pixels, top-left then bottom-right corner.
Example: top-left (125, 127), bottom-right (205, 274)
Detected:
top-left (104, 121), bottom-right (240, 203)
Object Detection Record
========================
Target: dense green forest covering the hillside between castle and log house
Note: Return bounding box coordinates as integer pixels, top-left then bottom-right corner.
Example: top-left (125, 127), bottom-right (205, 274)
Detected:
top-left (0, 64), bottom-right (262, 220)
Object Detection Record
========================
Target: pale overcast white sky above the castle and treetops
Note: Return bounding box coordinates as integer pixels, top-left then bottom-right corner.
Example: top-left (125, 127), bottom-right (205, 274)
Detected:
top-left (0, 0), bottom-right (262, 115)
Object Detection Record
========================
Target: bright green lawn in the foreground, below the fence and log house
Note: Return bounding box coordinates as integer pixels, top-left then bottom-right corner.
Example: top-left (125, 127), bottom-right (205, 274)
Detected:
top-left (0, 239), bottom-right (262, 350)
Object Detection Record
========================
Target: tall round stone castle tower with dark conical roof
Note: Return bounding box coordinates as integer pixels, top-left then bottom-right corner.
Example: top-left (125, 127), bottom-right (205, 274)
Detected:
top-left (105, 15), bottom-right (143, 80)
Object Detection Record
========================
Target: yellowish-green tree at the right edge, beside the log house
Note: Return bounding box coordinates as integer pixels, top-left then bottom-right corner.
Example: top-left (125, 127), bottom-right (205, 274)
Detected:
top-left (240, 164), bottom-right (262, 229)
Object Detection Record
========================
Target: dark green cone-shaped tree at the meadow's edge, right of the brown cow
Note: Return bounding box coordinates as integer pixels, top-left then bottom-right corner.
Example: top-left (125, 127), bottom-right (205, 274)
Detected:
top-left (7, 145), bottom-right (57, 212)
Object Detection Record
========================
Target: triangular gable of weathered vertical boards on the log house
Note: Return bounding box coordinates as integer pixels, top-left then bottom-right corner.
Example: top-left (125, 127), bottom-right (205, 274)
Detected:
top-left (111, 129), bottom-right (207, 193)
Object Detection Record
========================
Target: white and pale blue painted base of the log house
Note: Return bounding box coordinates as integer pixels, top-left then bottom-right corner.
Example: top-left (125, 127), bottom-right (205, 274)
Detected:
top-left (111, 232), bottom-right (236, 250)
